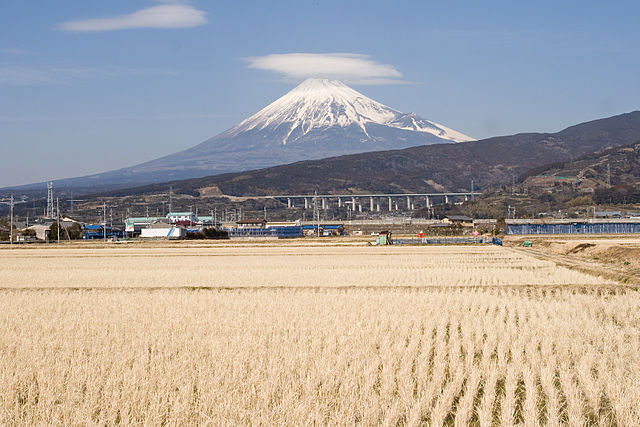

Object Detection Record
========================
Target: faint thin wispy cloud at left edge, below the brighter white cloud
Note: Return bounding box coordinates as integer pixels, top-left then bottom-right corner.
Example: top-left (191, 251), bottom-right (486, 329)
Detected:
top-left (0, 66), bottom-right (176, 86)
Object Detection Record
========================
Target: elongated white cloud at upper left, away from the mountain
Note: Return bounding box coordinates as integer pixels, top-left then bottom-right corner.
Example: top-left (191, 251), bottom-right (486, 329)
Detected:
top-left (58, 4), bottom-right (207, 32)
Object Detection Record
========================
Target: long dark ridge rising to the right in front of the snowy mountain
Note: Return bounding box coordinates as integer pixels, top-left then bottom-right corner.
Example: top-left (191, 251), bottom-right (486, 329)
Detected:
top-left (92, 111), bottom-right (640, 195)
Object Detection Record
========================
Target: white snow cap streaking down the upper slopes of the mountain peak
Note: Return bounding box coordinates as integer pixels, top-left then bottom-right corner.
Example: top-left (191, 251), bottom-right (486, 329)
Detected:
top-left (229, 78), bottom-right (473, 144)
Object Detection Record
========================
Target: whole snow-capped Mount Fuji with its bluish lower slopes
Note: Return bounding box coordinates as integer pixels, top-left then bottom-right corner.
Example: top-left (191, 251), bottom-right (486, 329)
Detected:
top-left (21, 78), bottom-right (473, 188)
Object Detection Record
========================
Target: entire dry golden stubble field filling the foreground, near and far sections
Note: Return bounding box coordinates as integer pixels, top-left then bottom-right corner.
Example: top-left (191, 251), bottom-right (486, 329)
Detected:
top-left (0, 247), bottom-right (640, 426)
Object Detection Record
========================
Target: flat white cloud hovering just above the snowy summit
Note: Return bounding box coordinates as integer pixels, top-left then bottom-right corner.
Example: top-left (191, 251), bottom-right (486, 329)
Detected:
top-left (247, 53), bottom-right (405, 84)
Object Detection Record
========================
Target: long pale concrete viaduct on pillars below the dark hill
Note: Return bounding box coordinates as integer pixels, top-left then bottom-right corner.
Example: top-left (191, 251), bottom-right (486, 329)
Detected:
top-left (263, 192), bottom-right (481, 212)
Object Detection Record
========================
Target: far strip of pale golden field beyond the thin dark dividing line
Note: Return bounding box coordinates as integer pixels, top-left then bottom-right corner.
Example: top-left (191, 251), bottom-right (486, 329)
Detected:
top-left (0, 246), bottom-right (607, 288)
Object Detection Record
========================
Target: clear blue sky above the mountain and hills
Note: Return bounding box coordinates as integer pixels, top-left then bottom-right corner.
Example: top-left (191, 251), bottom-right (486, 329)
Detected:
top-left (0, 0), bottom-right (640, 187)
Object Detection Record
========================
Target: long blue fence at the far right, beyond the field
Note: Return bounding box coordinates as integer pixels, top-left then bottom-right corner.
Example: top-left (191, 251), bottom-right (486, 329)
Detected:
top-left (505, 222), bottom-right (640, 234)
